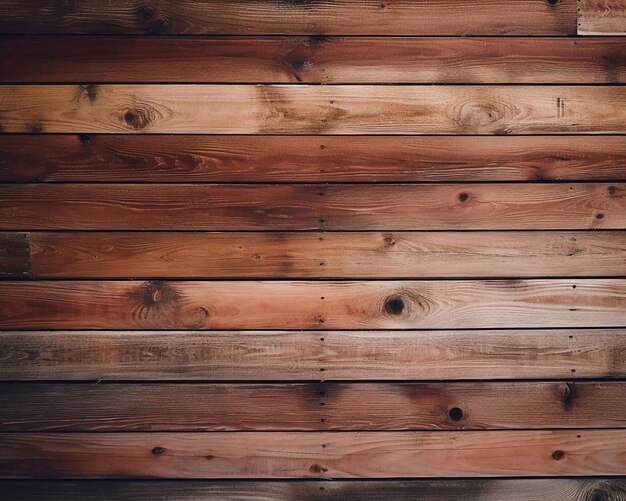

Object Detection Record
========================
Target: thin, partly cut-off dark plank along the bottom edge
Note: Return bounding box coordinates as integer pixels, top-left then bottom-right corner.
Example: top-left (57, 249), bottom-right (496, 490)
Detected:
top-left (0, 478), bottom-right (626, 501)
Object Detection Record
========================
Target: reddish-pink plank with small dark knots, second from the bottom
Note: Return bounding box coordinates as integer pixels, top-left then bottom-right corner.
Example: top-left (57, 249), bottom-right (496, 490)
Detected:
top-left (0, 430), bottom-right (626, 478)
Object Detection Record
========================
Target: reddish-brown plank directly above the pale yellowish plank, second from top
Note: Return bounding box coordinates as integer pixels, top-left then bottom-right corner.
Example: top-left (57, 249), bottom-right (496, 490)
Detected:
top-left (0, 36), bottom-right (626, 84)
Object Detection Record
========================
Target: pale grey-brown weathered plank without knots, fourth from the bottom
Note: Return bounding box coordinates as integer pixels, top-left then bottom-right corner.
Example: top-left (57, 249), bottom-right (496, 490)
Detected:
top-left (0, 329), bottom-right (626, 378)
